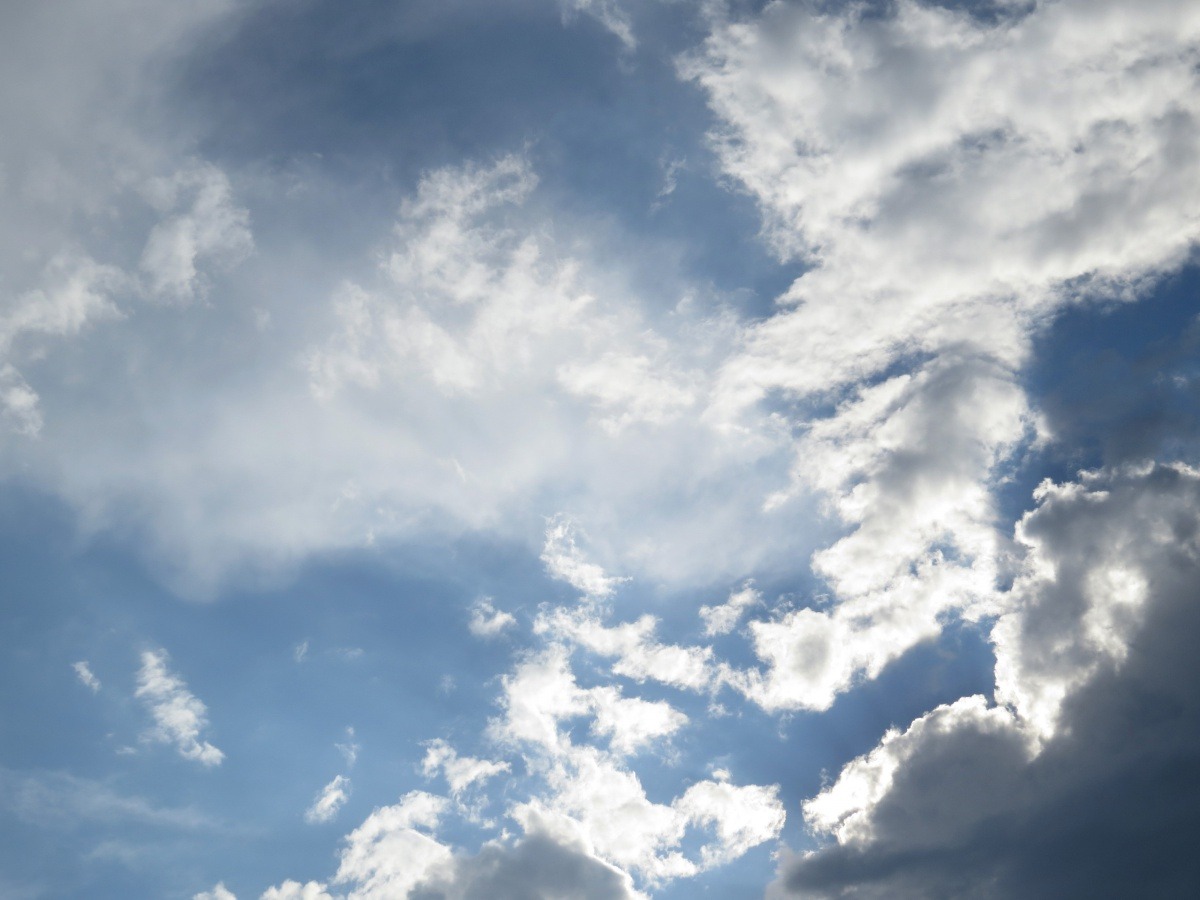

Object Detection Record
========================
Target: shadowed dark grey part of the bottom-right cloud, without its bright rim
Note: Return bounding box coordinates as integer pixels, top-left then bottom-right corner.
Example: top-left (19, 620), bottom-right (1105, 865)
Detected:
top-left (775, 466), bottom-right (1200, 898)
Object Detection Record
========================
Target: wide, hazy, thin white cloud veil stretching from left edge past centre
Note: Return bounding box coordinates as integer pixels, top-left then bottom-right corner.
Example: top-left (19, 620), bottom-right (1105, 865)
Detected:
top-left (0, 144), bottom-right (808, 596)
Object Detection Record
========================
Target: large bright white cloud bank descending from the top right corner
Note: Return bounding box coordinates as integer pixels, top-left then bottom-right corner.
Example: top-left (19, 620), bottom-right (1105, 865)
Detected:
top-left (682, 0), bottom-right (1200, 709)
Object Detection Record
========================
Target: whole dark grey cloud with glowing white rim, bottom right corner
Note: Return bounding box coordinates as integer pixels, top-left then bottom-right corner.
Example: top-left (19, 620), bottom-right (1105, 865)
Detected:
top-left (776, 464), bottom-right (1200, 898)
